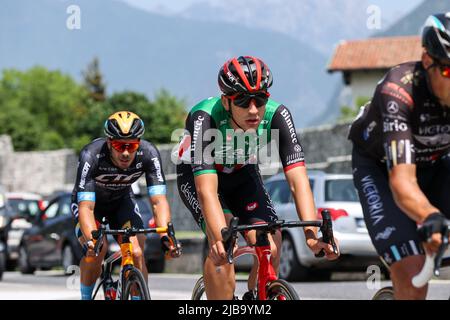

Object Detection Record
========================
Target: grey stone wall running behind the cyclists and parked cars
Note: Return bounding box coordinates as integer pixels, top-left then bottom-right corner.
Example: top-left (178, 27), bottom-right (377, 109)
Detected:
top-left (0, 124), bottom-right (351, 230)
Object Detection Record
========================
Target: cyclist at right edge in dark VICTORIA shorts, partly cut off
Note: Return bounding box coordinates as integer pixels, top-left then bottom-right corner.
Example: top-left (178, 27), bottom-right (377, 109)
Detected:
top-left (349, 12), bottom-right (450, 299)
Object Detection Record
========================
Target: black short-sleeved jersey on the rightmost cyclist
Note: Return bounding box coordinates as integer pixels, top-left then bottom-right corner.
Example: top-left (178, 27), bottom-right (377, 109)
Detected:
top-left (349, 61), bottom-right (450, 168)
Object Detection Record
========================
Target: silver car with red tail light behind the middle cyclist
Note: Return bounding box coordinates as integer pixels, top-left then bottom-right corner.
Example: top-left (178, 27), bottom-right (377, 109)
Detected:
top-left (265, 170), bottom-right (382, 280)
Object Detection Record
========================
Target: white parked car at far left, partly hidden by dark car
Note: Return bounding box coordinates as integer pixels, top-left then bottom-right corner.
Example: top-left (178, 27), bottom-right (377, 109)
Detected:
top-left (5, 192), bottom-right (44, 270)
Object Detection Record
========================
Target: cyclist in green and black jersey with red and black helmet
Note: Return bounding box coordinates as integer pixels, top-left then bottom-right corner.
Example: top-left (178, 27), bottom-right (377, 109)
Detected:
top-left (177, 56), bottom-right (337, 299)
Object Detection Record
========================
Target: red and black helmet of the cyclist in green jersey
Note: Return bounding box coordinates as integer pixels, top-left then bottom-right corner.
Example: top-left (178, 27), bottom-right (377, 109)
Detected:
top-left (218, 56), bottom-right (272, 95)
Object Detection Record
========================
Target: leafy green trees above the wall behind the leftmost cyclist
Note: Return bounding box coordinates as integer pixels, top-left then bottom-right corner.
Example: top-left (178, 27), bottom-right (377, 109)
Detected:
top-left (0, 61), bottom-right (186, 151)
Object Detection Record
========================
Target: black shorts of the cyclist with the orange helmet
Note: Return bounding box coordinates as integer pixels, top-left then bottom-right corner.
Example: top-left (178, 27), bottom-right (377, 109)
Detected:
top-left (71, 193), bottom-right (144, 249)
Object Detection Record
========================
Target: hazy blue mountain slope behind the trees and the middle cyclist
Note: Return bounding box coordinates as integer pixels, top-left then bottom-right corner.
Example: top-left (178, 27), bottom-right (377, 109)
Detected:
top-left (0, 0), bottom-right (336, 126)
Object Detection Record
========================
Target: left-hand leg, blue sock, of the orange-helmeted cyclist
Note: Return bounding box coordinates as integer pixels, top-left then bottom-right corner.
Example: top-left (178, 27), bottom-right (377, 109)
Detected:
top-left (71, 202), bottom-right (108, 300)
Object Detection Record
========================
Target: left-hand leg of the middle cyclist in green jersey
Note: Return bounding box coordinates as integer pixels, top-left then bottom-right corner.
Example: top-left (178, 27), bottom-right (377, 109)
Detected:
top-left (177, 164), bottom-right (235, 300)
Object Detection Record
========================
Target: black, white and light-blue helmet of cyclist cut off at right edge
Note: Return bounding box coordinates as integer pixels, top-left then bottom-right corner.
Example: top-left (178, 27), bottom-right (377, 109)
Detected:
top-left (422, 12), bottom-right (450, 61)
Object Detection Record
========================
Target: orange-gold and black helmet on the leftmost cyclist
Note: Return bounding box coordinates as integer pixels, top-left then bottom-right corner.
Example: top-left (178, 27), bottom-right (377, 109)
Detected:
top-left (104, 111), bottom-right (145, 139)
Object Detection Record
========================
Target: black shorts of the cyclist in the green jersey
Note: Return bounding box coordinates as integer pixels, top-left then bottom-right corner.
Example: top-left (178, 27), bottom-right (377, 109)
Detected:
top-left (177, 164), bottom-right (278, 232)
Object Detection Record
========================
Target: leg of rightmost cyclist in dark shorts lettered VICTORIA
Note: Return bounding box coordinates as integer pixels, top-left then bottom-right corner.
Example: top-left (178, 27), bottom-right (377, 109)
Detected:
top-left (352, 148), bottom-right (427, 299)
